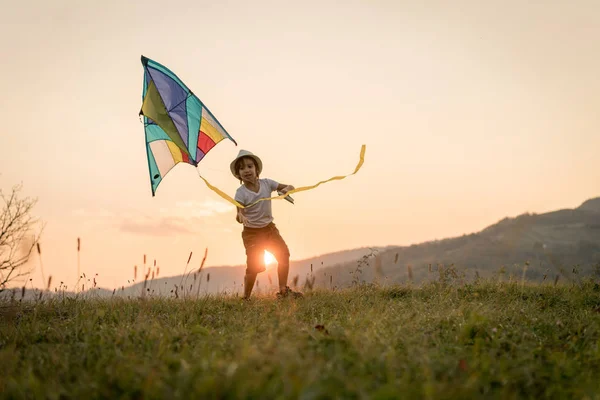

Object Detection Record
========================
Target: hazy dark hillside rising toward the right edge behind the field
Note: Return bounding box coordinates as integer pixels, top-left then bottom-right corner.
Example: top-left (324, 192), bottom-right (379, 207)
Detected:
top-left (316, 197), bottom-right (600, 287)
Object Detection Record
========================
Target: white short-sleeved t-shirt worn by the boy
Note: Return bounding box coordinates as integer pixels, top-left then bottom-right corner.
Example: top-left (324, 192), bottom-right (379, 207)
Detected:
top-left (235, 178), bottom-right (279, 228)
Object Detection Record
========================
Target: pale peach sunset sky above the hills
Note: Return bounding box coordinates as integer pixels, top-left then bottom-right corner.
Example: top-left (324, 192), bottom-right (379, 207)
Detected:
top-left (0, 0), bottom-right (600, 288)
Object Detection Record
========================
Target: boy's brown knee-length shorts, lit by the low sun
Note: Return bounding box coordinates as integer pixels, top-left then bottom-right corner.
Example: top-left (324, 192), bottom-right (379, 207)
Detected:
top-left (242, 222), bottom-right (290, 274)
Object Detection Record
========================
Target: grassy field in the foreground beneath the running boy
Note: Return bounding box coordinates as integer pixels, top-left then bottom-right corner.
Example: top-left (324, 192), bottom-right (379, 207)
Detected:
top-left (0, 281), bottom-right (600, 399)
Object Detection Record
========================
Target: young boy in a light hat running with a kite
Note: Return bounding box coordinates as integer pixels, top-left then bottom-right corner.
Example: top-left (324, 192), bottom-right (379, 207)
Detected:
top-left (230, 150), bottom-right (303, 300)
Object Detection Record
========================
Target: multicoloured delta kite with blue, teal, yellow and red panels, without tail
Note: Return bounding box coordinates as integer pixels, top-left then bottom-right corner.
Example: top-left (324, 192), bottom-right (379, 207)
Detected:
top-left (140, 56), bottom-right (237, 196)
